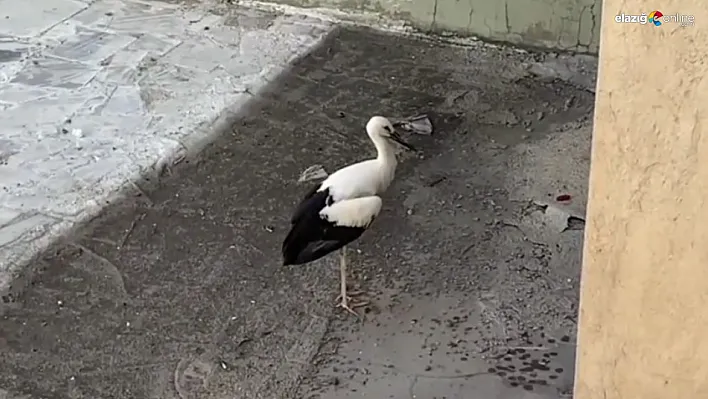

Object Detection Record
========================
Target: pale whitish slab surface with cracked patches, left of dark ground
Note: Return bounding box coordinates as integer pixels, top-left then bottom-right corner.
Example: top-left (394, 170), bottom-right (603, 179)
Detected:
top-left (0, 0), bottom-right (332, 292)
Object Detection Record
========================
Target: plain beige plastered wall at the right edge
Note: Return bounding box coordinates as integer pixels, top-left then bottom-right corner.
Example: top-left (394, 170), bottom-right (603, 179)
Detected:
top-left (575, 0), bottom-right (708, 399)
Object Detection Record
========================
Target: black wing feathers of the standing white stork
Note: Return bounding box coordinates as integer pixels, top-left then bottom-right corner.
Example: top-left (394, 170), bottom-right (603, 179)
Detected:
top-left (283, 186), bottom-right (366, 265)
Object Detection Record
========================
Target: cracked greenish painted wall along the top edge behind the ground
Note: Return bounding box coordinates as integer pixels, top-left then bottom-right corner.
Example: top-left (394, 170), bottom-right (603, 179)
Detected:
top-left (271, 0), bottom-right (602, 54)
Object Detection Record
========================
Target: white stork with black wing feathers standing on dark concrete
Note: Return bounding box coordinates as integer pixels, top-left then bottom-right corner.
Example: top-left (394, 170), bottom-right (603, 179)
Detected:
top-left (283, 116), bottom-right (415, 315)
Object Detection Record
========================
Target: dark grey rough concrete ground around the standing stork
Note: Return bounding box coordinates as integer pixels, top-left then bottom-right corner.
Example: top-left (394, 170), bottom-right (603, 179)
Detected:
top-left (0, 23), bottom-right (593, 399)
